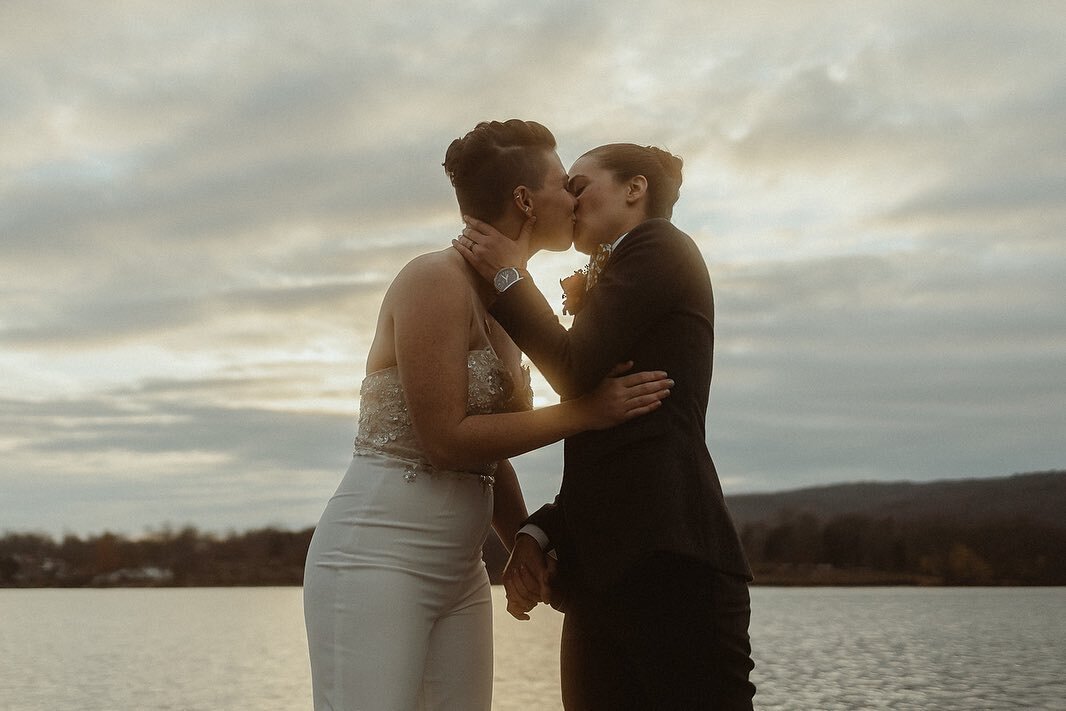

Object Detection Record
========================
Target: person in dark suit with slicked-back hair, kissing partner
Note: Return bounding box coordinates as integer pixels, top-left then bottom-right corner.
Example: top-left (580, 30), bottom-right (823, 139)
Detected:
top-left (453, 144), bottom-right (755, 711)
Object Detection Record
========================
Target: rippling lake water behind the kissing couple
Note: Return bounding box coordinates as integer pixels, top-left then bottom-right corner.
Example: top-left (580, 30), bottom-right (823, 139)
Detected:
top-left (0, 587), bottom-right (1066, 711)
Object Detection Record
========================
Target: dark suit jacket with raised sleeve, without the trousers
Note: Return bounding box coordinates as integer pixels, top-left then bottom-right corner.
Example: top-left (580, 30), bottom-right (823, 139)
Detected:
top-left (491, 220), bottom-right (750, 601)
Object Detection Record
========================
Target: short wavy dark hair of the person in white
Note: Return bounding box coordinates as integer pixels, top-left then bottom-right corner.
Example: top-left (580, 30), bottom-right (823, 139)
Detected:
top-left (442, 118), bottom-right (555, 221)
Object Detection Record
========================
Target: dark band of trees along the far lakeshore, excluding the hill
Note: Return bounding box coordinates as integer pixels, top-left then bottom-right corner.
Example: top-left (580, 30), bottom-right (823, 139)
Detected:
top-left (0, 512), bottom-right (1066, 587)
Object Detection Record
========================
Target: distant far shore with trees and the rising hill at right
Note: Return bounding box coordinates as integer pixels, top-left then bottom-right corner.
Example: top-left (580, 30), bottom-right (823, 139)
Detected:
top-left (0, 471), bottom-right (1066, 587)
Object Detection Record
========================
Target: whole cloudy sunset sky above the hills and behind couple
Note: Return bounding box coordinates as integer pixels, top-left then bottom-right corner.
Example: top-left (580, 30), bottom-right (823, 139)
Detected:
top-left (0, 0), bottom-right (1066, 535)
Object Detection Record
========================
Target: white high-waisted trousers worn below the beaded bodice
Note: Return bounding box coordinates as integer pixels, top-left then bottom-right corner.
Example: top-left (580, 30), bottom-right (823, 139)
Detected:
top-left (304, 455), bottom-right (492, 711)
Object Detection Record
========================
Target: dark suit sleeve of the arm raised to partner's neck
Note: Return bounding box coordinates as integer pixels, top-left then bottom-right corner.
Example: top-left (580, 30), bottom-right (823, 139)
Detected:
top-left (492, 221), bottom-right (688, 399)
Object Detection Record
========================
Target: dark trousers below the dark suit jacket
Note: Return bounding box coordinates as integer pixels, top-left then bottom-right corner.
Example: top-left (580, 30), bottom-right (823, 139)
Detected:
top-left (562, 554), bottom-right (755, 711)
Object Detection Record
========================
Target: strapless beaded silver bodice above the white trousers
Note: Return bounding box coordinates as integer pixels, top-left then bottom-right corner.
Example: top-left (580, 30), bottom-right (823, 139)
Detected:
top-left (355, 348), bottom-right (533, 481)
